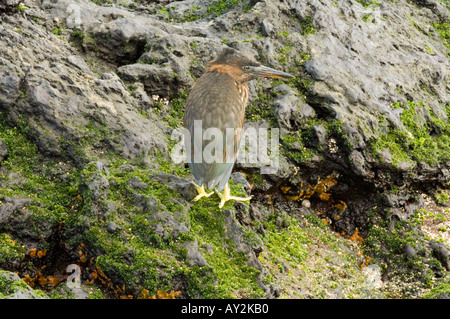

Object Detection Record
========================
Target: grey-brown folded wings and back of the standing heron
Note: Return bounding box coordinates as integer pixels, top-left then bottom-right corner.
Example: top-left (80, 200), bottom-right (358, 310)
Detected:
top-left (184, 74), bottom-right (245, 191)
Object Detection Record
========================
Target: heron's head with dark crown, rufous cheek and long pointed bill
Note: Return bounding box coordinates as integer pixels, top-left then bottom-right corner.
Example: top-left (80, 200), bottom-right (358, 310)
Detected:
top-left (205, 47), bottom-right (294, 83)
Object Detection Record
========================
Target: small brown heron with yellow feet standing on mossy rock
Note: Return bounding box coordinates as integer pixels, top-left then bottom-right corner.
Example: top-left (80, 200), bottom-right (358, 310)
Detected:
top-left (183, 47), bottom-right (294, 208)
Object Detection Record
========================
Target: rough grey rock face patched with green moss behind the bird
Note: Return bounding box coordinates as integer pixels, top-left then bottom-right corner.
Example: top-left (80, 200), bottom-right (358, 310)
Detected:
top-left (0, 0), bottom-right (450, 298)
